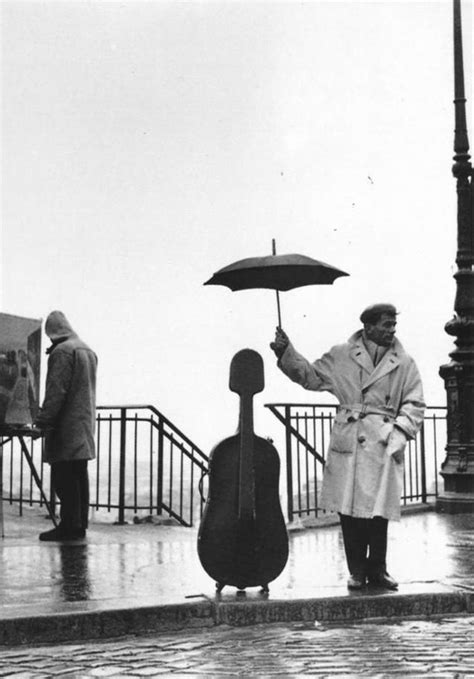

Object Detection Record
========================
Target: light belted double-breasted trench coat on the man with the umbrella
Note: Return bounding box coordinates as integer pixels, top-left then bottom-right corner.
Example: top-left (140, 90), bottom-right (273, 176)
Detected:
top-left (278, 330), bottom-right (425, 520)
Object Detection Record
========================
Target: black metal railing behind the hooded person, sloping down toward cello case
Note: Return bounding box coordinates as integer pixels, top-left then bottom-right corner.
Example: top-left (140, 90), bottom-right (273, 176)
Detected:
top-left (0, 405), bottom-right (208, 526)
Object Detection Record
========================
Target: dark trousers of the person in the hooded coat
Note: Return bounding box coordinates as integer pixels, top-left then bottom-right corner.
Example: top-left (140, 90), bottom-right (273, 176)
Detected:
top-left (51, 460), bottom-right (89, 532)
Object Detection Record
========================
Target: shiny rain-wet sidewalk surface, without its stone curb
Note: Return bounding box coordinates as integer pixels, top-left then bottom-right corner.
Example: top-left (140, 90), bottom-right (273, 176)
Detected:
top-left (0, 508), bottom-right (474, 613)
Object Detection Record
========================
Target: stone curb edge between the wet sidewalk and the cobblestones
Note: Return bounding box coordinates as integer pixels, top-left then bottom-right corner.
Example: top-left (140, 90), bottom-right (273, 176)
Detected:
top-left (0, 590), bottom-right (474, 646)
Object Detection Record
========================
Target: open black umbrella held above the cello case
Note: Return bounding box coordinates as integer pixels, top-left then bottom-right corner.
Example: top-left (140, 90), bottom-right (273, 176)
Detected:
top-left (204, 241), bottom-right (349, 326)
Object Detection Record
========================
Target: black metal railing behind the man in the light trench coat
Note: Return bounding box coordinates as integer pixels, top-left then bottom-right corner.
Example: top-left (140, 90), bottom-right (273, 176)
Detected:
top-left (265, 403), bottom-right (446, 521)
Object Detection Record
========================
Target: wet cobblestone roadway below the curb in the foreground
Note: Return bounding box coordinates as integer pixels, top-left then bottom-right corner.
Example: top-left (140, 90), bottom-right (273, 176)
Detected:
top-left (0, 616), bottom-right (474, 679)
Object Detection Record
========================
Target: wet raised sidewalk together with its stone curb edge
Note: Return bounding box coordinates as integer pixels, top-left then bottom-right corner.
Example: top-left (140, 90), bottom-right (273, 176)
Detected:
top-left (0, 504), bottom-right (474, 645)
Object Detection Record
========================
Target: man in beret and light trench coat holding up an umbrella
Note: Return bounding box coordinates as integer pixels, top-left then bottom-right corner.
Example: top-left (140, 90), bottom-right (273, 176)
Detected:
top-left (270, 304), bottom-right (425, 589)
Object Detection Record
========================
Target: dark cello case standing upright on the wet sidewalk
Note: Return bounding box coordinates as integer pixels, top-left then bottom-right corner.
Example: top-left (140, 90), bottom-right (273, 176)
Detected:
top-left (198, 349), bottom-right (288, 592)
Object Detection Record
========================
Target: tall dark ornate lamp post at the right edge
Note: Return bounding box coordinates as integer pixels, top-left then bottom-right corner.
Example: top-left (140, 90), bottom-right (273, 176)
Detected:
top-left (437, 0), bottom-right (474, 513)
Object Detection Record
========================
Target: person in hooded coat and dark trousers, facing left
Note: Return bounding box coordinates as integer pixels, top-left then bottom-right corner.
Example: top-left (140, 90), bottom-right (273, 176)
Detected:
top-left (35, 311), bottom-right (97, 540)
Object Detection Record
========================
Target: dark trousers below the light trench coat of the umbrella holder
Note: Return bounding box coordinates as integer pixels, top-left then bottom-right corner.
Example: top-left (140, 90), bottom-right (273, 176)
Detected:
top-left (339, 514), bottom-right (388, 577)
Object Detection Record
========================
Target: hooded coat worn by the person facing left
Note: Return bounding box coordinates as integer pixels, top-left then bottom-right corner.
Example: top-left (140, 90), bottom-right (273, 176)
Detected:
top-left (35, 311), bottom-right (97, 463)
